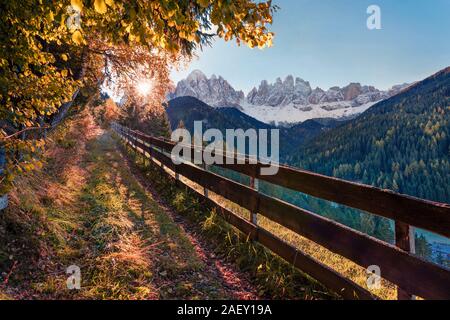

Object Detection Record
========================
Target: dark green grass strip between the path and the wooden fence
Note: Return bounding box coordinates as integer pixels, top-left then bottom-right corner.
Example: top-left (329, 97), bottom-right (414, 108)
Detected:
top-left (119, 135), bottom-right (337, 299)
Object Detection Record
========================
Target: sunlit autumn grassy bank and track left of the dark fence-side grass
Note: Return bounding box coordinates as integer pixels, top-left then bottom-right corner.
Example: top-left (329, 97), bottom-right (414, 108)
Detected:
top-left (0, 112), bottom-right (258, 299)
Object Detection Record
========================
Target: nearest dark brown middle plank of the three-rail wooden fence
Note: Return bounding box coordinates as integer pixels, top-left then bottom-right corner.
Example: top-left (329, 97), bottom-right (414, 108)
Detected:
top-left (259, 195), bottom-right (450, 299)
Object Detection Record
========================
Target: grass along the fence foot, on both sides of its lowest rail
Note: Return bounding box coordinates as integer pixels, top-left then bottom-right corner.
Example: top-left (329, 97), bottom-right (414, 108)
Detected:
top-left (123, 137), bottom-right (396, 299)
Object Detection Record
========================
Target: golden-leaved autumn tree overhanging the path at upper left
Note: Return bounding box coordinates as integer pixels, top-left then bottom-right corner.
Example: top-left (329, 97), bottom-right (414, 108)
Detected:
top-left (0, 0), bottom-right (276, 190)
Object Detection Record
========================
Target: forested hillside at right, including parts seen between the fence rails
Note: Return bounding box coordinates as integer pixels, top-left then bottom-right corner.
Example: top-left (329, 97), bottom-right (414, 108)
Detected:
top-left (202, 68), bottom-right (450, 265)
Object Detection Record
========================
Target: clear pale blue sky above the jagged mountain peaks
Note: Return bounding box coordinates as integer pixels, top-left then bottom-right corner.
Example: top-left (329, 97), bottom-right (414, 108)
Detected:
top-left (172, 0), bottom-right (450, 92)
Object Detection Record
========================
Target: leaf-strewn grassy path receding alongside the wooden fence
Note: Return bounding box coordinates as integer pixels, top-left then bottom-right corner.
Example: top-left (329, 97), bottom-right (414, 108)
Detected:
top-left (74, 132), bottom-right (255, 299)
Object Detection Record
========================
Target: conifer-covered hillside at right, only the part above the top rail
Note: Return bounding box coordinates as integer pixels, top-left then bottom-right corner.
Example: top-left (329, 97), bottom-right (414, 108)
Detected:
top-left (293, 68), bottom-right (450, 202)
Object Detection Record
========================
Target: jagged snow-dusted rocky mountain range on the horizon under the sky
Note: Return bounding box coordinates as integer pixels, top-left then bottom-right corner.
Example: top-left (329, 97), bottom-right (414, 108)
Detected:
top-left (169, 70), bottom-right (408, 124)
